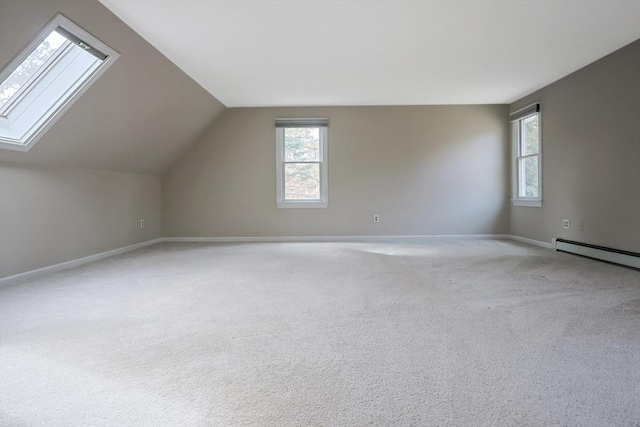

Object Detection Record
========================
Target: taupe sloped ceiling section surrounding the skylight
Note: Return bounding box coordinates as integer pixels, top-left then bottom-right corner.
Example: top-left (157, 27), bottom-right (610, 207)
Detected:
top-left (0, 0), bottom-right (225, 175)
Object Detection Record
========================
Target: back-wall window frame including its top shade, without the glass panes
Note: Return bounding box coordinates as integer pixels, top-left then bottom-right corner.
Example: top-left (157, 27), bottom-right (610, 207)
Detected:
top-left (276, 119), bottom-right (329, 208)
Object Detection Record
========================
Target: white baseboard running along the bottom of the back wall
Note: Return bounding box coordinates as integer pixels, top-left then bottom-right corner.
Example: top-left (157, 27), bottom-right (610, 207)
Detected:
top-left (162, 234), bottom-right (511, 243)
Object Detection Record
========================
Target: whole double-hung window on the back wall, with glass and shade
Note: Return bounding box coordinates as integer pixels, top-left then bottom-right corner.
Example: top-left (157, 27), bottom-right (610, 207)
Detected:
top-left (276, 118), bottom-right (329, 208)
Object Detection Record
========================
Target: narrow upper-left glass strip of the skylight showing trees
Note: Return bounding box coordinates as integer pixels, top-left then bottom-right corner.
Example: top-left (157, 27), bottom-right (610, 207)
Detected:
top-left (0, 31), bottom-right (67, 108)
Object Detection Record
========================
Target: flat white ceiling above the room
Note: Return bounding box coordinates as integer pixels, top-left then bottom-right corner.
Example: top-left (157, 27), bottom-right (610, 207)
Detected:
top-left (100, 0), bottom-right (640, 107)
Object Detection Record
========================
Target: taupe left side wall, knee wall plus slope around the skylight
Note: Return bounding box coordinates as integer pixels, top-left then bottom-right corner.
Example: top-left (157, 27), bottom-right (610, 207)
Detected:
top-left (0, 0), bottom-right (224, 277)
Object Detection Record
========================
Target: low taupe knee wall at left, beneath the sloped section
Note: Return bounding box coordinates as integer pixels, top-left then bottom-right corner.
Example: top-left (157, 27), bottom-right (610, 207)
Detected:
top-left (0, 163), bottom-right (161, 277)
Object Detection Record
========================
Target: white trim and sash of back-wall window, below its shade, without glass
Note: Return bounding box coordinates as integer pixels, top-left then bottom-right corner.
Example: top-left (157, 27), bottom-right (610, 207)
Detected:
top-left (276, 123), bottom-right (329, 208)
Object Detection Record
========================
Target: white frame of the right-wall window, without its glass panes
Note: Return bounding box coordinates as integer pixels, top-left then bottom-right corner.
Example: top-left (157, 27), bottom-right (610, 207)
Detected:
top-left (510, 102), bottom-right (543, 207)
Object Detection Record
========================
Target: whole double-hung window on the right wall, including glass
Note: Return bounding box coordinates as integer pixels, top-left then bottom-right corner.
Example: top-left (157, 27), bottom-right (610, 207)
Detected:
top-left (510, 103), bottom-right (542, 207)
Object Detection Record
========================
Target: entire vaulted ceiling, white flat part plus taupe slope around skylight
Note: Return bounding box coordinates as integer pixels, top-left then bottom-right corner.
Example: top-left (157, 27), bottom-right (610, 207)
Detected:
top-left (0, 0), bottom-right (640, 174)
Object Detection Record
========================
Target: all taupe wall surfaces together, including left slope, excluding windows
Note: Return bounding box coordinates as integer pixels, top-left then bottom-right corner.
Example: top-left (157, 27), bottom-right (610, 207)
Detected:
top-left (0, 0), bottom-right (640, 277)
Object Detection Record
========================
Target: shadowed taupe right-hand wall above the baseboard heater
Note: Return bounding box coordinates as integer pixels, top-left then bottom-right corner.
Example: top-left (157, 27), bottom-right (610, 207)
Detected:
top-left (511, 41), bottom-right (640, 252)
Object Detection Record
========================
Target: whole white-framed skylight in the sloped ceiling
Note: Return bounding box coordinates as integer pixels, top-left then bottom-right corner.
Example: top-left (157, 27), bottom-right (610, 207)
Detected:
top-left (0, 14), bottom-right (119, 151)
